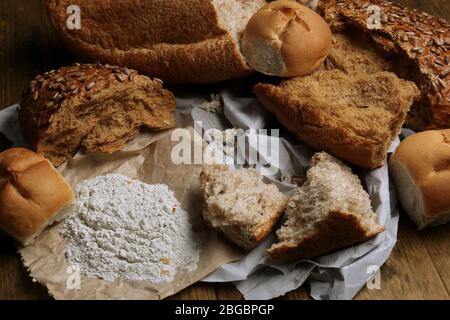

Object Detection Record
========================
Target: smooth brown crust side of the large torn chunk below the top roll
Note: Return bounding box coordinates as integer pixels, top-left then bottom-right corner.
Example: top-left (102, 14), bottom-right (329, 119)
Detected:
top-left (254, 71), bottom-right (418, 169)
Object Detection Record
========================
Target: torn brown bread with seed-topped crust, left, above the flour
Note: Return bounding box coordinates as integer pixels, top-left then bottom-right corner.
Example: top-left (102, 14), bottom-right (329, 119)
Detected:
top-left (19, 64), bottom-right (176, 165)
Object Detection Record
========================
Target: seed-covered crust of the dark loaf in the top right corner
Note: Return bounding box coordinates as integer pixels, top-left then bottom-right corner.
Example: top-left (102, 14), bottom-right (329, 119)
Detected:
top-left (318, 0), bottom-right (450, 130)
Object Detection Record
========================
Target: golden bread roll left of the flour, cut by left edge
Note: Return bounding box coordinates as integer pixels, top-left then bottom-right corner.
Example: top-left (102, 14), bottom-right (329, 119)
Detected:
top-left (0, 148), bottom-right (74, 245)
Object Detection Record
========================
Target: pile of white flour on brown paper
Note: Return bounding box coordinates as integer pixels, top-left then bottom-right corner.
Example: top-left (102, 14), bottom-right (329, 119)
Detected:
top-left (60, 174), bottom-right (201, 283)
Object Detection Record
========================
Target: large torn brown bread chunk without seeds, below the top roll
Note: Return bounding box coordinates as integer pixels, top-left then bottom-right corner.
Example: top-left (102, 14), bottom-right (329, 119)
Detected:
top-left (254, 69), bottom-right (419, 168)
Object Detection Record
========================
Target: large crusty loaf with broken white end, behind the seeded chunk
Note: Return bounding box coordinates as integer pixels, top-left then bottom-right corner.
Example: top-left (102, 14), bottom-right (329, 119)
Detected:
top-left (47, 0), bottom-right (267, 83)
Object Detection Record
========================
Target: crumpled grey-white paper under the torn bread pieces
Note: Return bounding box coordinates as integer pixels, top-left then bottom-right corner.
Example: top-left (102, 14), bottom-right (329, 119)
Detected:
top-left (0, 79), bottom-right (399, 299)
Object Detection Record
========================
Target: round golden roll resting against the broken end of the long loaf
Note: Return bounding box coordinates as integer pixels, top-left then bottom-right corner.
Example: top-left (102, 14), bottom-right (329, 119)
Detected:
top-left (241, 0), bottom-right (332, 77)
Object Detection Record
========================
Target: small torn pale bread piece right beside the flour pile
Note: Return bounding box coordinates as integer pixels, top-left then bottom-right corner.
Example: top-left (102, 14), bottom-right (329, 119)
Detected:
top-left (200, 165), bottom-right (287, 250)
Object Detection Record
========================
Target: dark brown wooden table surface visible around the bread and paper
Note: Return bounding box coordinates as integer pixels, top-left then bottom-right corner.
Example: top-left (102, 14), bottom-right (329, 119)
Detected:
top-left (0, 0), bottom-right (450, 299)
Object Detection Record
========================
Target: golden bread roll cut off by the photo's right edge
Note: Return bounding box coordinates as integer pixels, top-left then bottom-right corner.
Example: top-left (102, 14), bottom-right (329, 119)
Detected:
top-left (389, 129), bottom-right (450, 229)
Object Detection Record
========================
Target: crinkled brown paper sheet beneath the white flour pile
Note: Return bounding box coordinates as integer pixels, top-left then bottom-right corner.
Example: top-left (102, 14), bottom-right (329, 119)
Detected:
top-left (19, 128), bottom-right (244, 299)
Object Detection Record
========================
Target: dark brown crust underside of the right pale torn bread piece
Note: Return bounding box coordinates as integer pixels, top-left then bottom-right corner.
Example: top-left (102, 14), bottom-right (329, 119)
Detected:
top-left (267, 211), bottom-right (384, 261)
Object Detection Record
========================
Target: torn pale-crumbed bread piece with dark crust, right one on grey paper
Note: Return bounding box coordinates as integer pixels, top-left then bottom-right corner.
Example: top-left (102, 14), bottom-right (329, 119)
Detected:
top-left (267, 152), bottom-right (384, 261)
